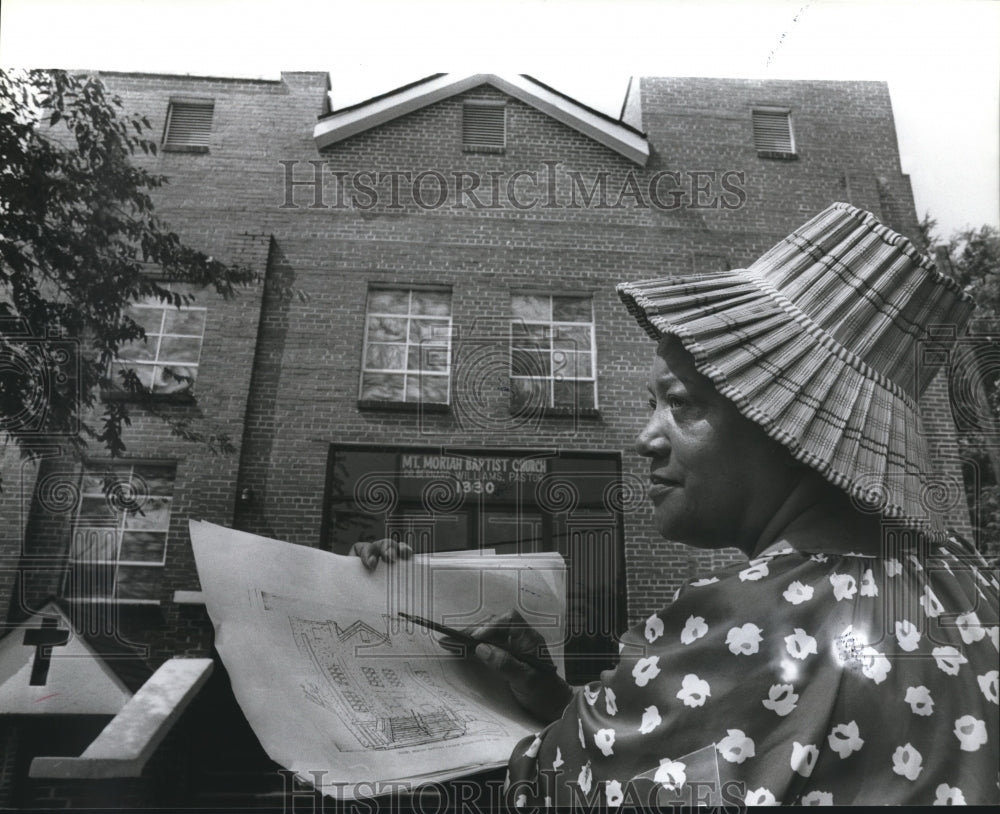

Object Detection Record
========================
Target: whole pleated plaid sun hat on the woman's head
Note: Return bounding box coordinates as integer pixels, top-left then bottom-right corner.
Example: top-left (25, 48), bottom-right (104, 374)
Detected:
top-left (618, 203), bottom-right (974, 532)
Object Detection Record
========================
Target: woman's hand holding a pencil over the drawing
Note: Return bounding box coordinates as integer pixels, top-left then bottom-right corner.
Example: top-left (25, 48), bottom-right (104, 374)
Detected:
top-left (458, 611), bottom-right (573, 723)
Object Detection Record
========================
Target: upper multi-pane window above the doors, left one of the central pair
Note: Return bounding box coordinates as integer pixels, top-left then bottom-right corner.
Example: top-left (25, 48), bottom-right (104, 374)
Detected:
top-left (360, 288), bottom-right (451, 412)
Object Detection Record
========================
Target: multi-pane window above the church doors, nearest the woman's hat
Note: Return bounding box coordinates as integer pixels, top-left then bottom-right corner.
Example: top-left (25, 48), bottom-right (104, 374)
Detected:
top-left (510, 294), bottom-right (597, 414)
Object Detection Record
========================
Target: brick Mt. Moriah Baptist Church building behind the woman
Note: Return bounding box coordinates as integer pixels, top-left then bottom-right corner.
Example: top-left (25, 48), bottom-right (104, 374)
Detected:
top-left (0, 73), bottom-right (968, 806)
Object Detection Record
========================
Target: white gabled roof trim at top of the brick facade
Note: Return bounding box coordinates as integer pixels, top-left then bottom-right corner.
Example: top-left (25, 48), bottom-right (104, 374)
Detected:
top-left (313, 74), bottom-right (649, 166)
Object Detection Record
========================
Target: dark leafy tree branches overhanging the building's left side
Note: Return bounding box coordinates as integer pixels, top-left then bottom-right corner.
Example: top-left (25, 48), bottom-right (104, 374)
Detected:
top-left (0, 70), bottom-right (257, 478)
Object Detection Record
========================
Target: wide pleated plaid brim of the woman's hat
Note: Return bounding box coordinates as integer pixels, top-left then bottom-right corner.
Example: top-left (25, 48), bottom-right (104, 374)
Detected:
top-left (618, 269), bottom-right (948, 534)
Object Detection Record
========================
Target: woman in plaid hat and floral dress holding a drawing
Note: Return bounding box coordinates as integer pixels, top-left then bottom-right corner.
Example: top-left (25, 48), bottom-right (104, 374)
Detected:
top-left (359, 204), bottom-right (1000, 807)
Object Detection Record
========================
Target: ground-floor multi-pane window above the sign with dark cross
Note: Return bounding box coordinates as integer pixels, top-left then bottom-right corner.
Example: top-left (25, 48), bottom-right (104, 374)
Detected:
top-left (63, 463), bottom-right (175, 602)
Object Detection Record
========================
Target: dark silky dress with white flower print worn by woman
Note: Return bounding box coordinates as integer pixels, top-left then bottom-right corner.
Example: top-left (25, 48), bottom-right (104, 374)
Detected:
top-left (508, 540), bottom-right (1000, 807)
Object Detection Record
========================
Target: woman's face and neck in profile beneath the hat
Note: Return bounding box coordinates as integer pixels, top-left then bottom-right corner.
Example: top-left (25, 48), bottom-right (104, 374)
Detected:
top-left (636, 336), bottom-right (796, 553)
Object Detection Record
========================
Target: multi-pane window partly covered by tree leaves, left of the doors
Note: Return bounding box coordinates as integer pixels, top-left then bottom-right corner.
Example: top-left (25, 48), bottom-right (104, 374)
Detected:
top-left (112, 286), bottom-right (207, 395)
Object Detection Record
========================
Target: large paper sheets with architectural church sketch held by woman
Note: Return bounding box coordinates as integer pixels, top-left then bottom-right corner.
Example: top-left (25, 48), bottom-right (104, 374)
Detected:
top-left (190, 522), bottom-right (565, 799)
